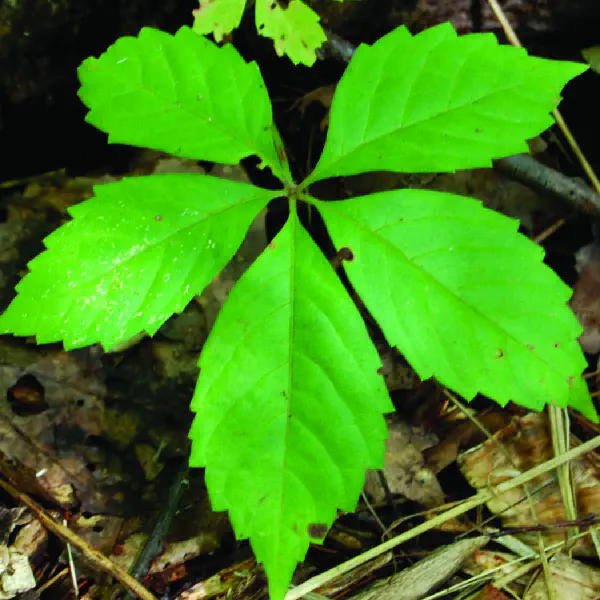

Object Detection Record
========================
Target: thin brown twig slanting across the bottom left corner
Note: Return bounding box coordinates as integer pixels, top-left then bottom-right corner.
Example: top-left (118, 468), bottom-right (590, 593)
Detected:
top-left (0, 479), bottom-right (156, 600)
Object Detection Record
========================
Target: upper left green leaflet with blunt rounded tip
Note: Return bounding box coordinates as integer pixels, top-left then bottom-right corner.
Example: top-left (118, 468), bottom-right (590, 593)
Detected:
top-left (78, 27), bottom-right (291, 181)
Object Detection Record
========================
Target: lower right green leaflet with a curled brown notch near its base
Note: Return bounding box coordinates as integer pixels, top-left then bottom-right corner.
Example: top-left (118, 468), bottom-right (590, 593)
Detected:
top-left (316, 190), bottom-right (597, 422)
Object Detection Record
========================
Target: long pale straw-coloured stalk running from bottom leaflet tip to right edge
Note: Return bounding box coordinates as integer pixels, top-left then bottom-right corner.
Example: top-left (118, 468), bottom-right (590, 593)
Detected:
top-left (285, 435), bottom-right (600, 600)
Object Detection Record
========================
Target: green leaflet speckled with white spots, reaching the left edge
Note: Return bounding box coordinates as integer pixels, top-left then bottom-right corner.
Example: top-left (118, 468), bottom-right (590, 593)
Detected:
top-left (0, 174), bottom-right (280, 349)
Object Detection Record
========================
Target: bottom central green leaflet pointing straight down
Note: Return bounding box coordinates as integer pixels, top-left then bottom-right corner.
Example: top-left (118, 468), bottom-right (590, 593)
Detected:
top-left (190, 207), bottom-right (393, 600)
